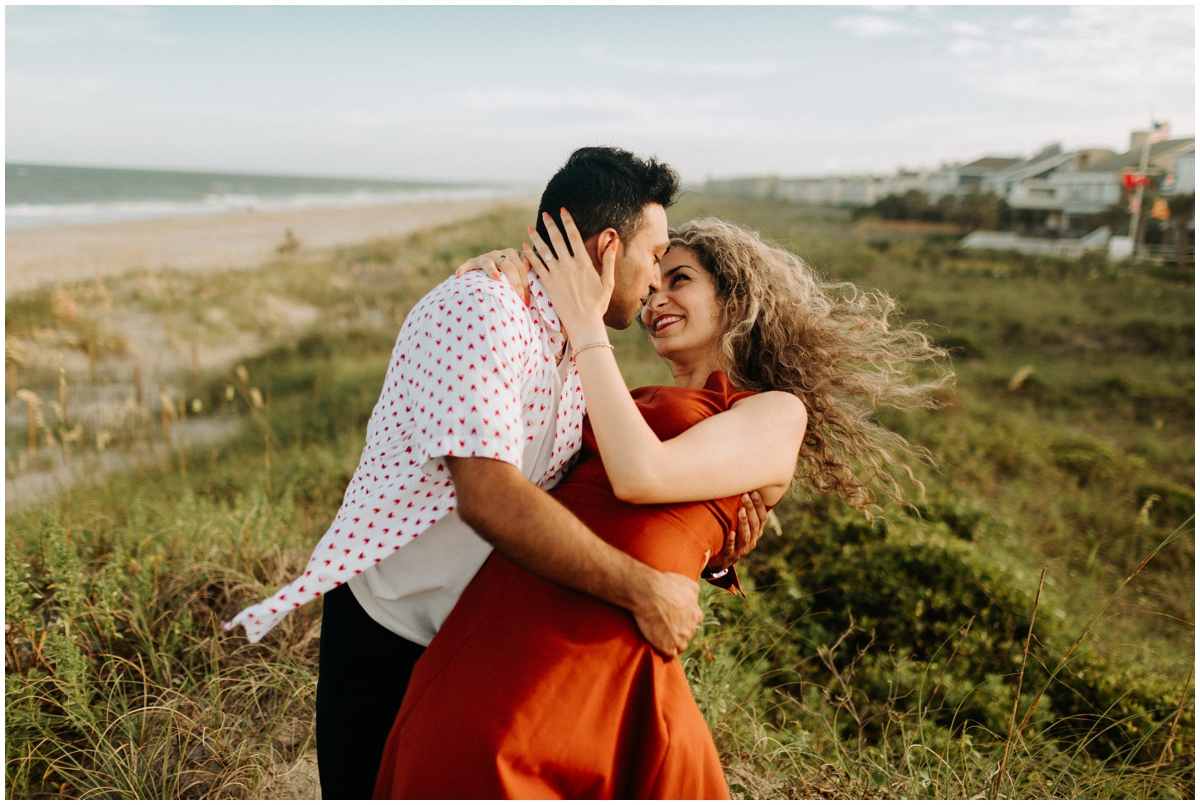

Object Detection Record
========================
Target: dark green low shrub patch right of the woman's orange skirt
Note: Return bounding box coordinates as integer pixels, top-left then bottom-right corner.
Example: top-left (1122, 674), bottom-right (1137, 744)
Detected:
top-left (739, 500), bottom-right (1194, 762)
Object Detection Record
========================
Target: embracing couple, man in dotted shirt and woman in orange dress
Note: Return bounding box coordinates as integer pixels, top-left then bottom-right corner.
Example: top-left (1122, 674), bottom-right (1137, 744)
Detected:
top-left (226, 148), bottom-right (947, 799)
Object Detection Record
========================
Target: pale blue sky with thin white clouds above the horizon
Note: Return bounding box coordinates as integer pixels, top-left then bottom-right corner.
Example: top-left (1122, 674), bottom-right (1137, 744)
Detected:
top-left (5, 5), bottom-right (1195, 184)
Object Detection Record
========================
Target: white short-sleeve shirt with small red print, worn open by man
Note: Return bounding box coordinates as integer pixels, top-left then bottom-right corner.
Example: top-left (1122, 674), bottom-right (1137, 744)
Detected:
top-left (226, 271), bottom-right (584, 642)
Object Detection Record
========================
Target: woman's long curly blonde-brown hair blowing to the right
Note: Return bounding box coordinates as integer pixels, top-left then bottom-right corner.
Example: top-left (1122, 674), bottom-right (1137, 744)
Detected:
top-left (671, 218), bottom-right (954, 513)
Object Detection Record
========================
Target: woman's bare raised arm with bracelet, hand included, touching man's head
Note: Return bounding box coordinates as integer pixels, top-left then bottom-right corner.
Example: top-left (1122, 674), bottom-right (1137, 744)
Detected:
top-left (527, 211), bottom-right (808, 505)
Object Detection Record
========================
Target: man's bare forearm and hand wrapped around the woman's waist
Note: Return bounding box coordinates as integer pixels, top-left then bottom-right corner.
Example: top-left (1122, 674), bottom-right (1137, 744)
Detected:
top-left (446, 457), bottom-right (702, 656)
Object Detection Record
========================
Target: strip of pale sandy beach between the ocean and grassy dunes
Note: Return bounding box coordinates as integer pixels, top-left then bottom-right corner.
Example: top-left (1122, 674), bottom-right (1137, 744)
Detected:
top-left (5, 198), bottom-right (536, 298)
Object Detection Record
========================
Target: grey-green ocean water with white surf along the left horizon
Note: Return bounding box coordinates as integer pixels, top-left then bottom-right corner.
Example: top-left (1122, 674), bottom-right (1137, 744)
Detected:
top-left (4, 163), bottom-right (530, 228)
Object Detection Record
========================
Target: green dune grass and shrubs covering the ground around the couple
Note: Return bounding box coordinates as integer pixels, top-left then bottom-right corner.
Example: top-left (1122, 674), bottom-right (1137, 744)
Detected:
top-left (5, 197), bottom-right (1195, 798)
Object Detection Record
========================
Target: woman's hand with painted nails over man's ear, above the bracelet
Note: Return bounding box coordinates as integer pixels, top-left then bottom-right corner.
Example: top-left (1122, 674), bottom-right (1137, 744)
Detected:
top-left (526, 209), bottom-right (619, 344)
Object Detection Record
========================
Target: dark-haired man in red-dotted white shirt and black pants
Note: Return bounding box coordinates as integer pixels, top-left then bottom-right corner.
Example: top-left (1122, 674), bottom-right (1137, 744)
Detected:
top-left (227, 148), bottom-right (761, 799)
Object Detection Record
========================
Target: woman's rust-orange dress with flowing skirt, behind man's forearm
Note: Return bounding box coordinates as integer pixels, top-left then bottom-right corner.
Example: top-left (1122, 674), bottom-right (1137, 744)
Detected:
top-left (374, 372), bottom-right (746, 799)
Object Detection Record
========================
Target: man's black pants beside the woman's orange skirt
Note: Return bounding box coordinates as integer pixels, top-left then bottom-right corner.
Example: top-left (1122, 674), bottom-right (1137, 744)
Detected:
top-left (317, 584), bottom-right (425, 799)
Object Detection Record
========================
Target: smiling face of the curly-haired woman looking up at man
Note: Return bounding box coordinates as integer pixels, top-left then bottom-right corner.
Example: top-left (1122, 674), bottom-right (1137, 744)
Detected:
top-left (642, 246), bottom-right (721, 362)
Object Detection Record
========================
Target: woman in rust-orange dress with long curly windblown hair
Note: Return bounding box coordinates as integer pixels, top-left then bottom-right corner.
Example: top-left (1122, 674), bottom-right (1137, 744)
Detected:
top-left (376, 211), bottom-right (948, 799)
